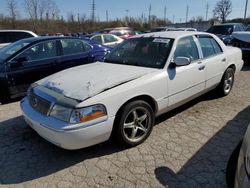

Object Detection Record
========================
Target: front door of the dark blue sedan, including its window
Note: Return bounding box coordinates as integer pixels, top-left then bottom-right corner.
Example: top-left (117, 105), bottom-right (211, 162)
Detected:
top-left (9, 41), bottom-right (58, 94)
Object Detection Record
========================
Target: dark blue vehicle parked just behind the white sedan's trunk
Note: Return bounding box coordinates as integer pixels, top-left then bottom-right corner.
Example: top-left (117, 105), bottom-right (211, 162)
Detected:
top-left (207, 23), bottom-right (246, 45)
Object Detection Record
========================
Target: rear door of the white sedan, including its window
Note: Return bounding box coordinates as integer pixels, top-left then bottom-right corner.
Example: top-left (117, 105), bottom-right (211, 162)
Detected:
top-left (197, 35), bottom-right (227, 88)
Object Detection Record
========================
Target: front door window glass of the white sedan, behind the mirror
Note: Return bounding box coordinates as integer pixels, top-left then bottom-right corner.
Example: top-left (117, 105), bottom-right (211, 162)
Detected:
top-left (174, 36), bottom-right (199, 62)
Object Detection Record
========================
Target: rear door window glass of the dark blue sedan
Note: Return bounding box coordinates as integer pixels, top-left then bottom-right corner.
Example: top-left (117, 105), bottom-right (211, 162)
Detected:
top-left (60, 39), bottom-right (92, 55)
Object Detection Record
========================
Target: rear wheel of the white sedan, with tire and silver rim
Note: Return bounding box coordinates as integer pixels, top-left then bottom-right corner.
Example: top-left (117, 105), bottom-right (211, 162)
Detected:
top-left (217, 68), bottom-right (234, 96)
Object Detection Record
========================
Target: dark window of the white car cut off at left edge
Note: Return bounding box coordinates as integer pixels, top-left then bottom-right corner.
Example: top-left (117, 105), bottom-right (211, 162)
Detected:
top-left (0, 31), bottom-right (33, 43)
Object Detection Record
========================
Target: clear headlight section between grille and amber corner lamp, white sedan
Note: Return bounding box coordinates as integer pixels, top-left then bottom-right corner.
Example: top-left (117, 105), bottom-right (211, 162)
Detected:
top-left (50, 104), bottom-right (72, 122)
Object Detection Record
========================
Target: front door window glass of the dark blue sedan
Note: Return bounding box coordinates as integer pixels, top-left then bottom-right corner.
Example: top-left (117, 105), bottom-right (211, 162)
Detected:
top-left (19, 41), bottom-right (57, 61)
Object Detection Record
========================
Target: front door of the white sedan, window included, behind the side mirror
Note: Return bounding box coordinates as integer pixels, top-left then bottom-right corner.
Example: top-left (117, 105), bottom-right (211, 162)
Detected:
top-left (168, 36), bottom-right (205, 106)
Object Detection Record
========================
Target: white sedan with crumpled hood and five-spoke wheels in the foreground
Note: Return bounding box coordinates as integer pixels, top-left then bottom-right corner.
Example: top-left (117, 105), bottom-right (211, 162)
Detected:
top-left (21, 31), bottom-right (243, 149)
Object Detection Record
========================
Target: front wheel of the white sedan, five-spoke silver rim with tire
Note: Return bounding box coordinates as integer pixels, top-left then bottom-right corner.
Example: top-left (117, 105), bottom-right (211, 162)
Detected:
top-left (114, 100), bottom-right (155, 147)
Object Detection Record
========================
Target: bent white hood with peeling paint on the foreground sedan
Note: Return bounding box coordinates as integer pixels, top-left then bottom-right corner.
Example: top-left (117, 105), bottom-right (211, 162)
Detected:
top-left (37, 62), bottom-right (157, 101)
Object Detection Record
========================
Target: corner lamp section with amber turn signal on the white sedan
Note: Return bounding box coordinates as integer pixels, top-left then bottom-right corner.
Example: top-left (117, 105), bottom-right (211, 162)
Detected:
top-left (70, 104), bottom-right (107, 123)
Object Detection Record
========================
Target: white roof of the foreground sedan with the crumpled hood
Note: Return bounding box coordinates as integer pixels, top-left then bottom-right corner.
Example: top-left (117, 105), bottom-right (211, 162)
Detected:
top-left (131, 31), bottom-right (211, 39)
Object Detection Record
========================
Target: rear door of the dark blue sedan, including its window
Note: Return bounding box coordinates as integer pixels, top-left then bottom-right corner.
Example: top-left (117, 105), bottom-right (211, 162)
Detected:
top-left (53, 39), bottom-right (95, 72)
